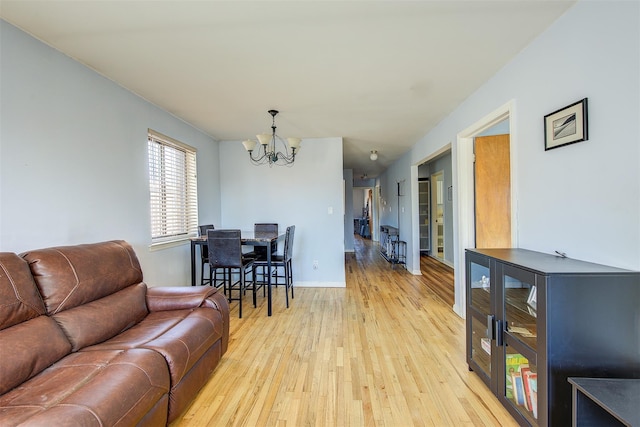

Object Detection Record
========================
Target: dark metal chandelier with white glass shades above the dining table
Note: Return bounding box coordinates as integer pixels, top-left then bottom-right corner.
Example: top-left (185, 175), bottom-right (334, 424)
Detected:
top-left (242, 110), bottom-right (301, 166)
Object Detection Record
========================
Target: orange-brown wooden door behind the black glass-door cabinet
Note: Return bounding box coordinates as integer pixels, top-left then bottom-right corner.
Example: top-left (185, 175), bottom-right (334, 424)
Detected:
top-left (474, 135), bottom-right (511, 248)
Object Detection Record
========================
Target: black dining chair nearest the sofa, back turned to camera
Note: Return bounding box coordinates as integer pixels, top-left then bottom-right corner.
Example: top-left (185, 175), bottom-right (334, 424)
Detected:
top-left (207, 230), bottom-right (256, 318)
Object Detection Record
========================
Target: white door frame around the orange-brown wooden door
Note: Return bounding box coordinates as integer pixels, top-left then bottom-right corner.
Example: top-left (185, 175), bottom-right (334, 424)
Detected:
top-left (453, 100), bottom-right (518, 318)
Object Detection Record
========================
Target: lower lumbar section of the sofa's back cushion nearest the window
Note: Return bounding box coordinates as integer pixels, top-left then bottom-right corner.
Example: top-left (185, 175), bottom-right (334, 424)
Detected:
top-left (52, 283), bottom-right (148, 351)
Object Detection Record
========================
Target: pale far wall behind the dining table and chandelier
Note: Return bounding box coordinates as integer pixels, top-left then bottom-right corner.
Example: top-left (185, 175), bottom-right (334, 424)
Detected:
top-left (215, 138), bottom-right (346, 287)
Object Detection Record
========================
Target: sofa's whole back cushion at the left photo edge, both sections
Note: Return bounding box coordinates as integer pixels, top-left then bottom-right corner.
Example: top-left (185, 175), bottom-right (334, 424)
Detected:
top-left (0, 253), bottom-right (71, 394)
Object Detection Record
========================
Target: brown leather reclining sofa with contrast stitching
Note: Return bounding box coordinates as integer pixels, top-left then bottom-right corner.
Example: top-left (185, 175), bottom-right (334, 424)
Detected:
top-left (0, 241), bottom-right (229, 427)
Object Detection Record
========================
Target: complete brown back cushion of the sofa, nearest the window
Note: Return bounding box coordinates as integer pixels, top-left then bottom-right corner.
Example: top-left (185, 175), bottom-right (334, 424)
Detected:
top-left (22, 240), bottom-right (148, 351)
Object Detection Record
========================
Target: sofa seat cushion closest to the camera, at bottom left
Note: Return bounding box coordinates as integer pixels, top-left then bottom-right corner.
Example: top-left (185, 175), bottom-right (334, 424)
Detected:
top-left (0, 349), bottom-right (169, 426)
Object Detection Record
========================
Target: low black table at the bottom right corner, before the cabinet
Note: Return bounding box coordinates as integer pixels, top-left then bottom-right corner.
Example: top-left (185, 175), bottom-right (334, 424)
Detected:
top-left (569, 377), bottom-right (640, 427)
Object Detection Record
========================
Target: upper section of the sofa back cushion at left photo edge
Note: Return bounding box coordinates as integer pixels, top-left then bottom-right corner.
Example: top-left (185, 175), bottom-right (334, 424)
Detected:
top-left (0, 252), bottom-right (45, 330)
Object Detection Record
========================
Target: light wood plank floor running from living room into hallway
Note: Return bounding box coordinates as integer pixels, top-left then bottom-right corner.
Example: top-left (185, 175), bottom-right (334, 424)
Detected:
top-left (172, 236), bottom-right (516, 427)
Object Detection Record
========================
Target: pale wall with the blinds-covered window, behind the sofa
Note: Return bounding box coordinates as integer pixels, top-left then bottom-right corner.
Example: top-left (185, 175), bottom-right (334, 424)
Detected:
top-left (0, 21), bottom-right (220, 286)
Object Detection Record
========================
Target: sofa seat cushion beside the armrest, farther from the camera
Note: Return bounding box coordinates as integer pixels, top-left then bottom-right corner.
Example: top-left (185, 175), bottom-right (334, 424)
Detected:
top-left (82, 308), bottom-right (223, 387)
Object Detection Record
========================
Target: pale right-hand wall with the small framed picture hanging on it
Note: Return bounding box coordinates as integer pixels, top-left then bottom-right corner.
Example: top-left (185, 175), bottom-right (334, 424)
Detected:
top-left (381, 1), bottom-right (640, 314)
